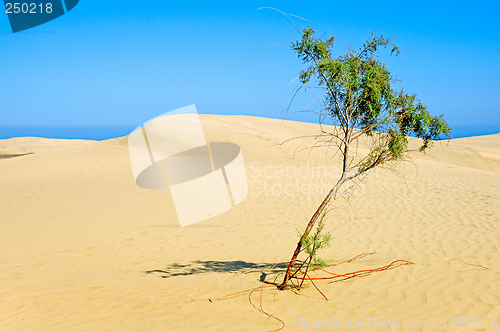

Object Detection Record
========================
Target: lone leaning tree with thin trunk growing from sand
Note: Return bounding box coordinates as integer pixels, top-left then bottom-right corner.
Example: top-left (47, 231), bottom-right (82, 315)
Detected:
top-left (273, 14), bottom-right (451, 289)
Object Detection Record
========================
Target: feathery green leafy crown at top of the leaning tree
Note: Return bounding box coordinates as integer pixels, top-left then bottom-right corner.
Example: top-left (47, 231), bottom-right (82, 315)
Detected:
top-left (291, 27), bottom-right (451, 158)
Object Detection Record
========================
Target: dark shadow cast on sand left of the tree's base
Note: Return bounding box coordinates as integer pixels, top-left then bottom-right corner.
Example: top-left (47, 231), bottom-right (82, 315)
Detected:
top-left (146, 261), bottom-right (287, 278)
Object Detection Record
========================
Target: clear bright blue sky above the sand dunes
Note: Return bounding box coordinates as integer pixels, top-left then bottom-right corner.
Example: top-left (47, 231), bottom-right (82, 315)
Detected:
top-left (0, 0), bottom-right (500, 138)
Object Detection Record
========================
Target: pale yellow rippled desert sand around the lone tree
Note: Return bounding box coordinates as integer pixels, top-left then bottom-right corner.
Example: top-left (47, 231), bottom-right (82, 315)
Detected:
top-left (0, 116), bottom-right (500, 332)
